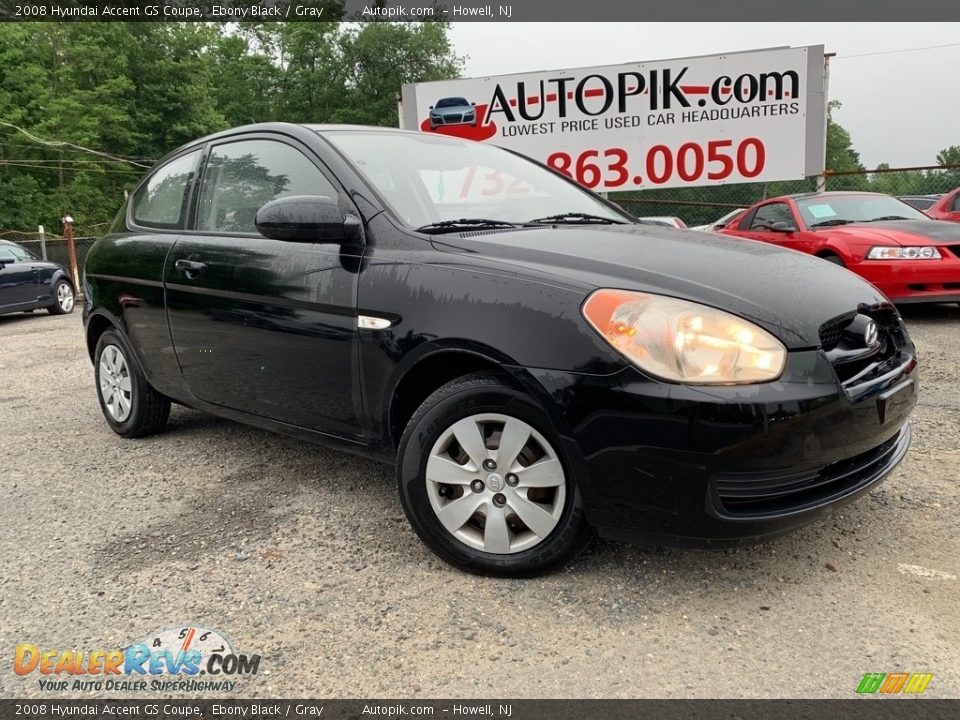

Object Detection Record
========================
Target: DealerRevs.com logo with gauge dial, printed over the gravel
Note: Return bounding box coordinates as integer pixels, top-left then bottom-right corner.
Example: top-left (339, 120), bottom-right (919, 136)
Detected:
top-left (13, 625), bottom-right (261, 692)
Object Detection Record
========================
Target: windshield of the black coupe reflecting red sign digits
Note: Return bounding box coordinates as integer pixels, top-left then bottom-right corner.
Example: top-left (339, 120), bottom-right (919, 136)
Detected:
top-left (322, 130), bottom-right (630, 227)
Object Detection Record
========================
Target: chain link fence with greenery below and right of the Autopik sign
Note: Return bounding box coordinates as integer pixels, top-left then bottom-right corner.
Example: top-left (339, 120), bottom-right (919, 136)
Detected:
top-left (610, 165), bottom-right (960, 227)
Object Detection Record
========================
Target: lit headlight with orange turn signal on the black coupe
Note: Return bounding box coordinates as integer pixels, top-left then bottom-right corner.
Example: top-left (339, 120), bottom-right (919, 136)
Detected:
top-left (582, 289), bottom-right (787, 385)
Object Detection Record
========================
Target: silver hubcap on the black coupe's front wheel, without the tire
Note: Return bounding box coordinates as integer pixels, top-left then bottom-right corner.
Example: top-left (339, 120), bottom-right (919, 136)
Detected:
top-left (426, 413), bottom-right (567, 555)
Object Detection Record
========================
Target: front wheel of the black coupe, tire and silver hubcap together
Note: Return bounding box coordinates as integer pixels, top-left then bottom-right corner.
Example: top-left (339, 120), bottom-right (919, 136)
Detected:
top-left (397, 373), bottom-right (589, 577)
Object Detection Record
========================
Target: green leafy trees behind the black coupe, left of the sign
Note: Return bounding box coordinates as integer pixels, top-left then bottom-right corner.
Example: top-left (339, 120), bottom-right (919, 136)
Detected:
top-left (0, 20), bottom-right (462, 231)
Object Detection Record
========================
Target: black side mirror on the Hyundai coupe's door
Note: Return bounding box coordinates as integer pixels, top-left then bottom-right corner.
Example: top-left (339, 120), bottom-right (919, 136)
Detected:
top-left (254, 195), bottom-right (349, 243)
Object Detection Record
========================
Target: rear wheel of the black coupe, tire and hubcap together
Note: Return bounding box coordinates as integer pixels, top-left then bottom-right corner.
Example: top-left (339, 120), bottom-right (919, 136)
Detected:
top-left (93, 330), bottom-right (170, 438)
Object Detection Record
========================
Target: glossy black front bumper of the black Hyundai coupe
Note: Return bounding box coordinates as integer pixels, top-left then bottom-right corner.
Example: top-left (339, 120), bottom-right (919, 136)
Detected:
top-left (529, 343), bottom-right (919, 546)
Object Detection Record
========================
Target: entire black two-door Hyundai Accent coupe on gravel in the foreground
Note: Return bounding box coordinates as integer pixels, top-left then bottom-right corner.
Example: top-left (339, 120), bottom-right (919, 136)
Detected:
top-left (84, 124), bottom-right (918, 575)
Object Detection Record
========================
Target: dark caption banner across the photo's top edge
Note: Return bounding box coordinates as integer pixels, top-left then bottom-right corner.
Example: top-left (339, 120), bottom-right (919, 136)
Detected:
top-left (0, 0), bottom-right (958, 21)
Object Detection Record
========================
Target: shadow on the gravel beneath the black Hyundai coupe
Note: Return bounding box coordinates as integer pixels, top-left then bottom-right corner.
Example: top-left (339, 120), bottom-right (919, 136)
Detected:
top-left (97, 407), bottom-right (908, 593)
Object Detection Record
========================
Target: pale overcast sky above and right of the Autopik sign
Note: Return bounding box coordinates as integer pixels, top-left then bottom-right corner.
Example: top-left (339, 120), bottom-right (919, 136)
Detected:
top-left (452, 22), bottom-right (960, 168)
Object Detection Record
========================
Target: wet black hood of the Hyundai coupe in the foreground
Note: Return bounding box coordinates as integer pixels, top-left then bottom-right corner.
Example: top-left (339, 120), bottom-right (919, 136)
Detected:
top-left (435, 225), bottom-right (888, 349)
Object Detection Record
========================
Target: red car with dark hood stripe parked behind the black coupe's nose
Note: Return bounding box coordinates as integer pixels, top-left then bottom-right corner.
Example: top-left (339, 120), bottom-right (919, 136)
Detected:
top-left (719, 192), bottom-right (960, 303)
